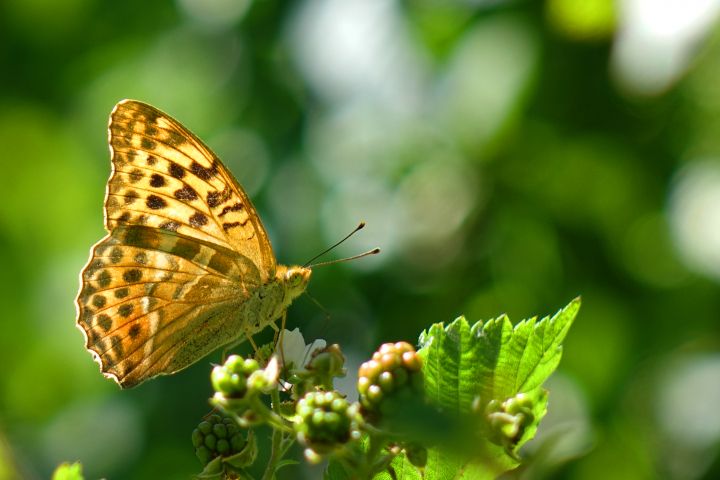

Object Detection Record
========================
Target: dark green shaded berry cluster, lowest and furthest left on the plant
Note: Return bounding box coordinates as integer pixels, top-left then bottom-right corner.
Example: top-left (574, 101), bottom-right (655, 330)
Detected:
top-left (192, 414), bottom-right (247, 465)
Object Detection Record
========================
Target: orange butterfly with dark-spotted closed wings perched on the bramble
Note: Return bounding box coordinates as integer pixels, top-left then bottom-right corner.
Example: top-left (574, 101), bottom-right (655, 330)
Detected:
top-left (76, 100), bottom-right (311, 388)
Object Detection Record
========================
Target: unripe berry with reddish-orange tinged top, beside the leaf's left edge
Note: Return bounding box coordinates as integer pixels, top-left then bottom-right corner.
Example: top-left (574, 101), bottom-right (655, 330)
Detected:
top-left (358, 342), bottom-right (423, 412)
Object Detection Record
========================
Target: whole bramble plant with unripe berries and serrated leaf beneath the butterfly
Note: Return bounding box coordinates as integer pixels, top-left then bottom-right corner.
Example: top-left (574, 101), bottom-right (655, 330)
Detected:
top-left (192, 299), bottom-right (580, 480)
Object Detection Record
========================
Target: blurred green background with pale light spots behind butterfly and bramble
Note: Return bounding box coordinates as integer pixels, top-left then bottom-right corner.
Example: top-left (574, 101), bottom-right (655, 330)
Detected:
top-left (0, 0), bottom-right (720, 480)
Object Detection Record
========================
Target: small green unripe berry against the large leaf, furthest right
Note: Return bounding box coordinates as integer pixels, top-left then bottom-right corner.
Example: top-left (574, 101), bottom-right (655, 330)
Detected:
top-left (485, 393), bottom-right (535, 447)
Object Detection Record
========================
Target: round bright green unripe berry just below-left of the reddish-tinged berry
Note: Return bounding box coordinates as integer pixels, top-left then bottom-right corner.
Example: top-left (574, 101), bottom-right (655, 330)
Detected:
top-left (295, 391), bottom-right (361, 455)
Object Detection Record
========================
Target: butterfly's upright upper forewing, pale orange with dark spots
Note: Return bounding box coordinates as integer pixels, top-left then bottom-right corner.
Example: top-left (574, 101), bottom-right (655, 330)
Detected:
top-left (105, 100), bottom-right (275, 274)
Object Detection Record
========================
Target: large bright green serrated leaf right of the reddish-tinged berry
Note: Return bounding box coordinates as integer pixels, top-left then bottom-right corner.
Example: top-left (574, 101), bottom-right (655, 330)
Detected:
top-left (418, 298), bottom-right (580, 480)
